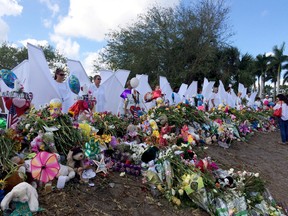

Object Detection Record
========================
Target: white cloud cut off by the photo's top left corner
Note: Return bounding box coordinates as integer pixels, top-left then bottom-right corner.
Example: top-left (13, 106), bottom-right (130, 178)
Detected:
top-left (0, 0), bottom-right (23, 17)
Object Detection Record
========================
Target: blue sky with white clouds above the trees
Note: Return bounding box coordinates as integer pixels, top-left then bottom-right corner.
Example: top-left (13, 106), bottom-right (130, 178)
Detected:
top-left (0, 0), bottom-right (288, 74)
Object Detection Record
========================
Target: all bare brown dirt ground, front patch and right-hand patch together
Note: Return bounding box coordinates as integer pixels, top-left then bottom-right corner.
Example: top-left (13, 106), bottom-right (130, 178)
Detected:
top-left (37, 131), bottom-right (288, 216)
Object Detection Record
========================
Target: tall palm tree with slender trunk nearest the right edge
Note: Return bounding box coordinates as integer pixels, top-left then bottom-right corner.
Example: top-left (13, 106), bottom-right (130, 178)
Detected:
top-left (271, 42), bottom-right (288, 94)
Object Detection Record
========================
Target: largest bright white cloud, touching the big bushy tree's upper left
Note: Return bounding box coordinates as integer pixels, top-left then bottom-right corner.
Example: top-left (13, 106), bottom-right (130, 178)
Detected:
top-left (54, 0), bottom-right (180, 41)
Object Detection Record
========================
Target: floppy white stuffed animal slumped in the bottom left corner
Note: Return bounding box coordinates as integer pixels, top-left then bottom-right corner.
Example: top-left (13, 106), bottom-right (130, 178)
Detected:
top-left (1, 182), bottom-right (39, 212)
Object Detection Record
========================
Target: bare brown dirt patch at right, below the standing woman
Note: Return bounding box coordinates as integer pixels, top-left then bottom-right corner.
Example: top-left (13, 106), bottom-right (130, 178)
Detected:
top-left (206, 131), bottom-right (288, 204)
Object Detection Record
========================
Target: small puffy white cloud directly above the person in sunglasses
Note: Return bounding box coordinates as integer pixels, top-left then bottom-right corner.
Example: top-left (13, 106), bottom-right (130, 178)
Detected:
top-left (50, 35), bottom-right (80, 59)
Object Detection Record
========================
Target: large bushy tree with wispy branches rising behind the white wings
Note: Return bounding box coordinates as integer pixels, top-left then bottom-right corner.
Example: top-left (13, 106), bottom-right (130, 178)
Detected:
top-left (101, 0), bottom-right (232, 88)
